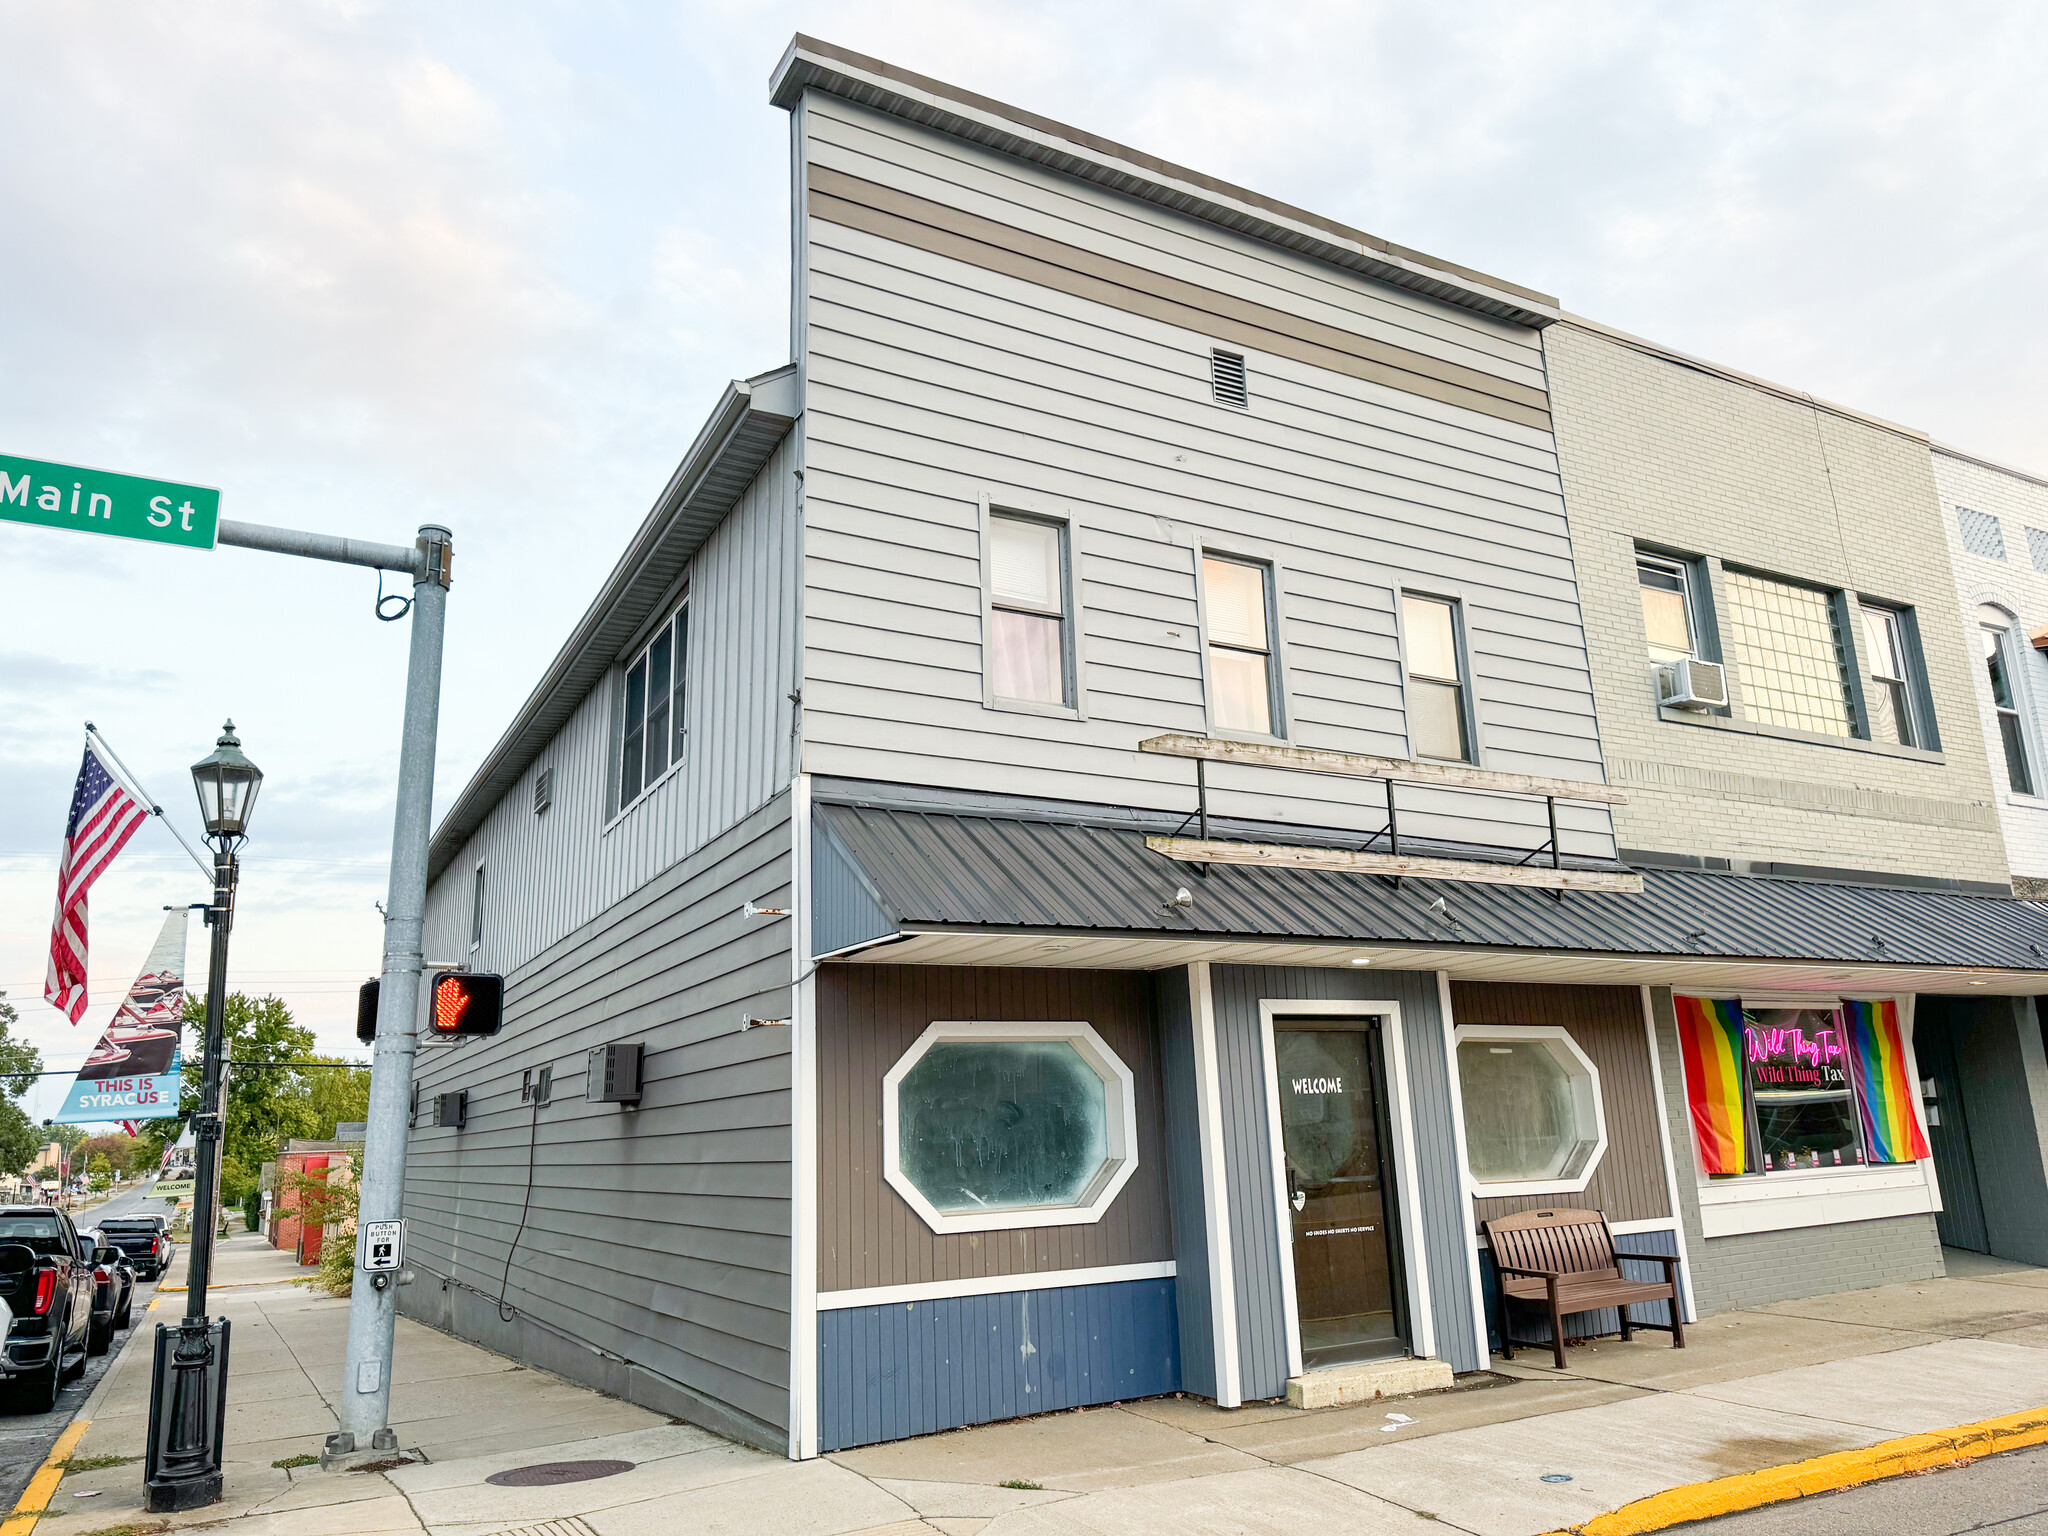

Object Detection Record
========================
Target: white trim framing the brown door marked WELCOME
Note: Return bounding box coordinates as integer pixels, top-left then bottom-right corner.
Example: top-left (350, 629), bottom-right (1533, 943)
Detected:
top-left (1260, 997), bottom-right (1438, 1376)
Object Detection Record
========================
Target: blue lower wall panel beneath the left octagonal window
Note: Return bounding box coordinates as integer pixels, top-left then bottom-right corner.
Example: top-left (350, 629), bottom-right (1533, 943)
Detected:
top-left (817, 1280), bottom-right (1180, 1450)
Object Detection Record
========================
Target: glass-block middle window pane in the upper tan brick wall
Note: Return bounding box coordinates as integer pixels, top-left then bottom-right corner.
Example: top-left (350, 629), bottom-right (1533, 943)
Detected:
top-left (1726, 569), bottom-right (1853, 735)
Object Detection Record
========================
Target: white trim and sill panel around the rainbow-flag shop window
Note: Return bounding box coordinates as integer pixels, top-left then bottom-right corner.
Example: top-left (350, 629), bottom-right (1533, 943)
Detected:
top-left (1673, 991), bottom-right (1942, 1237)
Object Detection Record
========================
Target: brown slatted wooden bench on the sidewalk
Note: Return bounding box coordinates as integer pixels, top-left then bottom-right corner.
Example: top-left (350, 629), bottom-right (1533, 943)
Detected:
top-left (1481, 1210), bottom-right (1686, 1370)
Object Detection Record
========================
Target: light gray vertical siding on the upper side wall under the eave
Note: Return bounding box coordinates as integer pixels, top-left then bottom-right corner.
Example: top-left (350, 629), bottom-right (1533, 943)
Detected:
top-left (426, 438), bottom-right (799, 973)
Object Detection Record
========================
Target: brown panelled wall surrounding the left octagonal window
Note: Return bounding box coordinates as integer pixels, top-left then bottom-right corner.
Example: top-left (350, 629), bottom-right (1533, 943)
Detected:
top-left (817, 965), bottom-right (1174, 1292)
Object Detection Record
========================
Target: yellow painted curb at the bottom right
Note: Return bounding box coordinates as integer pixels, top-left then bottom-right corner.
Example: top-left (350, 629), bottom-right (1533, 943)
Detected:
top-left (1540, 1407), bottom-right (2048, 1536)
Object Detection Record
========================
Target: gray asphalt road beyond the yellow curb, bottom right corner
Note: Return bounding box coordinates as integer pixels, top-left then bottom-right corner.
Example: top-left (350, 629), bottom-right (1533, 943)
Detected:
top-left (1681, 1446), bottom-right (2048, 1536)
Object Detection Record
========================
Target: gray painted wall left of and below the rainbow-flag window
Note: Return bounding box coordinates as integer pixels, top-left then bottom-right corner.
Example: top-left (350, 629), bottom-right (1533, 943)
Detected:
top-left (1651, 987), bottom-right (1942, 1317)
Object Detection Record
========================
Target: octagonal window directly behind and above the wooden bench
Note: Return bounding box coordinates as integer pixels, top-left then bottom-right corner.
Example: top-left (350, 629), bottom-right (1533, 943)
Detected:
top-left (1458, 1024), bottom-right (1608, 1194)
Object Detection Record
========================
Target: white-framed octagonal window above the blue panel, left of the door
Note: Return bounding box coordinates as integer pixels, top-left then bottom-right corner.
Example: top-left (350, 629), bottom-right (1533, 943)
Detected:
top-left (885, 1022), bottom-right (1137, 1231)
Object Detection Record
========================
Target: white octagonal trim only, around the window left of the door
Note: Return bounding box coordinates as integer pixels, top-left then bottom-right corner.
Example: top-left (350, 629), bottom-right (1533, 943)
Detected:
top-left (883, 1020), bottom-right (1139, 1233)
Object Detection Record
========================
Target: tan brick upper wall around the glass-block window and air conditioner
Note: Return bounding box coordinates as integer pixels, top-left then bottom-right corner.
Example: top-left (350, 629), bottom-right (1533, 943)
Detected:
top-left (1544, 322), bottom-right (2007, 883)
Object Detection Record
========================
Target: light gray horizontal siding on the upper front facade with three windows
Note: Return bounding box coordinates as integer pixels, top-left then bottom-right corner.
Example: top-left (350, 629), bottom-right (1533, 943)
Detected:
top-left (797, 92), bottom-right (1612, 868)
